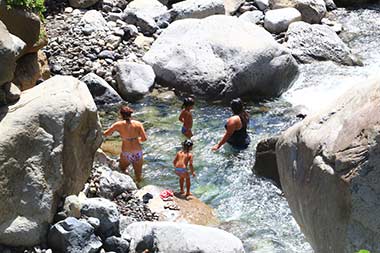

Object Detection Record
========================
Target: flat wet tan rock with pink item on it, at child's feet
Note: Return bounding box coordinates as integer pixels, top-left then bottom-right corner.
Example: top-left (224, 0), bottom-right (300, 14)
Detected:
top-left (134, 185), bottom-right (219, 224)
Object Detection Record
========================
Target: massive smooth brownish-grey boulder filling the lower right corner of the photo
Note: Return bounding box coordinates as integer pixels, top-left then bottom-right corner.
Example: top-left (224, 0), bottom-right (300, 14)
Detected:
top-left (276, 78), bottom-right (380, 253)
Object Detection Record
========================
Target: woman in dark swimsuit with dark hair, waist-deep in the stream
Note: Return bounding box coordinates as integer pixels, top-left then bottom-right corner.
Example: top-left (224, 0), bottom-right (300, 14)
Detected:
top-left (212, 98), bottom-right (250, 151)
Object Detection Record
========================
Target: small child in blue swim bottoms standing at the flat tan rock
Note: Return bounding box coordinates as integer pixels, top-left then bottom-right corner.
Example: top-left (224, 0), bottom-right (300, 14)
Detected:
top-left (173, 140), bottom-right (195, 197)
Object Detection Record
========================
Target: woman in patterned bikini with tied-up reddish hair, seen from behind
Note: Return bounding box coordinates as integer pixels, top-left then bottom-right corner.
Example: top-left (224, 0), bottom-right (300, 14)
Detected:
top-left (103, 106), bottom-right (147, 182)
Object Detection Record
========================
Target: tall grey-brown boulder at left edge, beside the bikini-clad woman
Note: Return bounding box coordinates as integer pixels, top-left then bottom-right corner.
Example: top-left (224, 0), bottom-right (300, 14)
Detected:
top-left (0, 76), bottom-right (101, 246)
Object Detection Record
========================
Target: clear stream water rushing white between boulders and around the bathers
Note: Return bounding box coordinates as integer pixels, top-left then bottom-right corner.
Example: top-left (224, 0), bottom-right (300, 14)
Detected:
top-left (98, 6), bottom-right (380, 253)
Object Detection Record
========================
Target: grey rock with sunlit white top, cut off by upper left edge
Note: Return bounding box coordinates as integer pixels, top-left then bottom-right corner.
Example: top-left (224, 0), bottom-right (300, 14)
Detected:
top-left (0, 21), bottom-right (25, 87)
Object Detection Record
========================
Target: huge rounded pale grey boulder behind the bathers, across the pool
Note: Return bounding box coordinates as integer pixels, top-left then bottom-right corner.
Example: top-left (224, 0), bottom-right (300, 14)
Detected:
top-left (143, 15), bottom-right (298, 99)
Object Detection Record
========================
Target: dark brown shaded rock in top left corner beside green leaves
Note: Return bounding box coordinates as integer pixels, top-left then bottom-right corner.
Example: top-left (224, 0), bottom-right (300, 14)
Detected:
top-left (0, 0), bottom-right (41, 53)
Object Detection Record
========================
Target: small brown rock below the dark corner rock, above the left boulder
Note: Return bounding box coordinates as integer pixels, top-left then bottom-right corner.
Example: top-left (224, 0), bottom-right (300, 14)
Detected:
top-left (13, 53), bottom-right (41, 91)
